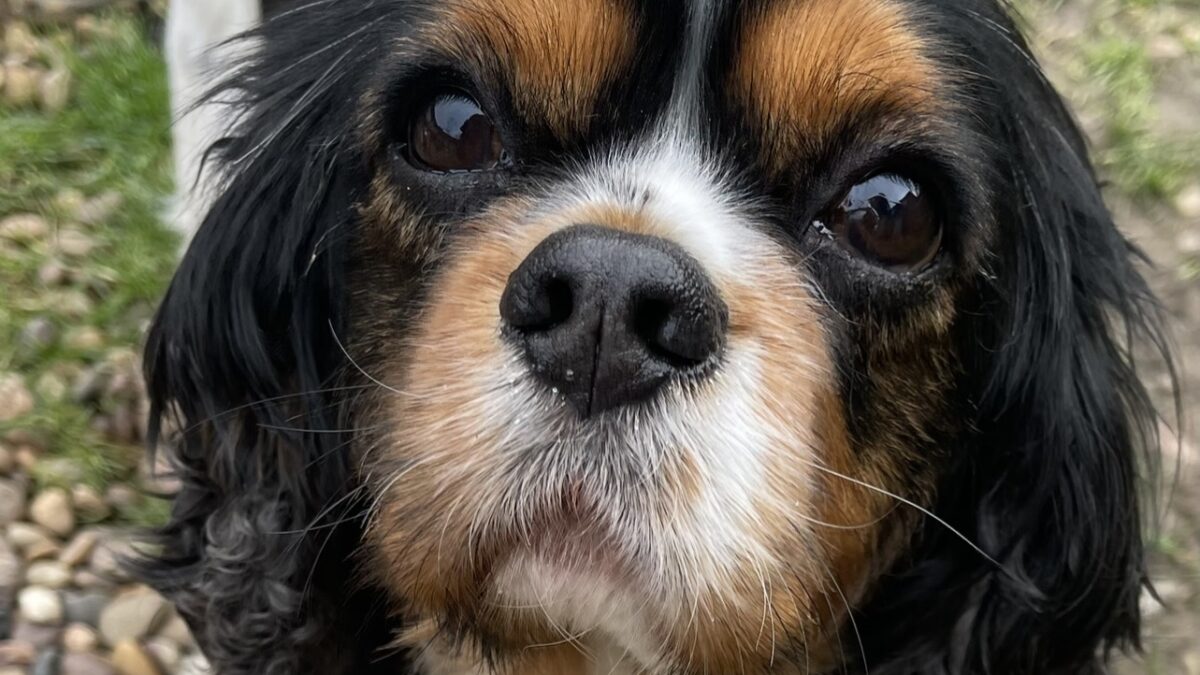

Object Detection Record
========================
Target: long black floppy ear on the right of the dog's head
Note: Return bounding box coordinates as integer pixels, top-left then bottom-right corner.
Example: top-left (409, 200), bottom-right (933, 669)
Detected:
top-left (859, 2), bottom-right (1170, 674)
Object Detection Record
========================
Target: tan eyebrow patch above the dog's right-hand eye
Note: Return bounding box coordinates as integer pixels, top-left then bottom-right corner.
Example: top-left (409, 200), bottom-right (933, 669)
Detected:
top-left (730, 0), bottom-right (940, 168)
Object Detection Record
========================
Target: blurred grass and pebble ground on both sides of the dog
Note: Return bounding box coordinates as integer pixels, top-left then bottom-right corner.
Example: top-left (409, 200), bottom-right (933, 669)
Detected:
top-left (0, 0), bottom-right (1200, 675)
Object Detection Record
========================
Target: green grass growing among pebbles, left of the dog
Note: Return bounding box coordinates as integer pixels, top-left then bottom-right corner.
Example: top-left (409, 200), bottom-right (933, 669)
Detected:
top-left (0, 14), bottom-right (176, 511)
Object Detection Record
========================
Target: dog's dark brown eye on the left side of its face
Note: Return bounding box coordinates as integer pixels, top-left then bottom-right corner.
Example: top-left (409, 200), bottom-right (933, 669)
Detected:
top-left (408, 92), bottom-right (508, 172)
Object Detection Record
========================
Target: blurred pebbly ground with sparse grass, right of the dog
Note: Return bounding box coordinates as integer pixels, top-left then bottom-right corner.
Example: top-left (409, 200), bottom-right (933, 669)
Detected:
top-left (1022, 0), bottom-right (1200, 675)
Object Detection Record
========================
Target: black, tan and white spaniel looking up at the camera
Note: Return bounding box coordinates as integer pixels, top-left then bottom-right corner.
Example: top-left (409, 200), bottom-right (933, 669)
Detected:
top-left (147, 0), bottom-right (1169, 675)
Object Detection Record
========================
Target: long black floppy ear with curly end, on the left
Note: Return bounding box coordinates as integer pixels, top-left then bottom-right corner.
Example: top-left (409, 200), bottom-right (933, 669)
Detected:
top-left (139, 2), bottom-right (412, 675)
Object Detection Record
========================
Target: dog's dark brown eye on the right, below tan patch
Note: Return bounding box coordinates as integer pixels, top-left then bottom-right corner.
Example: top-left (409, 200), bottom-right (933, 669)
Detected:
top-left (815, 173), bottom-right (942, 271)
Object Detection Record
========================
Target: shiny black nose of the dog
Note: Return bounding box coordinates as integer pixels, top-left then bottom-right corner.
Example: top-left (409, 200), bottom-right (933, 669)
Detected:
top-left (500, 225), bottom-right (728, 417)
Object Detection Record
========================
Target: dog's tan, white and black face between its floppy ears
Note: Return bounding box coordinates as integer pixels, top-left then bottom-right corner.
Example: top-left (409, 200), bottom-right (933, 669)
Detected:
top-left (348, 0), bottom-right (974, 673)
